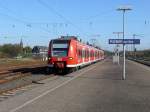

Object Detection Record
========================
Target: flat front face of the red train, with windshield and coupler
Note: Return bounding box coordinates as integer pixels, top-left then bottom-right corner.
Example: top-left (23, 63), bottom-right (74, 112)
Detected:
top-left (48, 39), bottom-right (70, 72)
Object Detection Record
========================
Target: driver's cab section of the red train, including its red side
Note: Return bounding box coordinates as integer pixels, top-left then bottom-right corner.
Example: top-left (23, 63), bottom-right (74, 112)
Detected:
top-left (48, 37), bottom-right (76, 70)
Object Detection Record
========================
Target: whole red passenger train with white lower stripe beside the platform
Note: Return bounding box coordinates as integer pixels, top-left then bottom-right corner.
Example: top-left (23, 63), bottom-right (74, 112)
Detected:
top-left (47, 36), bottom-right (104, 72)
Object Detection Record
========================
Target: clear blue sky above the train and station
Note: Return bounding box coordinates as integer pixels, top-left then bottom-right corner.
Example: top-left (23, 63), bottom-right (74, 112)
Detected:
top-left (0, 0), bottom-right (150, 50)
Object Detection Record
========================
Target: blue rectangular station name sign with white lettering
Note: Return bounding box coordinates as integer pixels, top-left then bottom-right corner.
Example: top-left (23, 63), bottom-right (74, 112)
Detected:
top-left (109, 39), bottom-right (140, 44)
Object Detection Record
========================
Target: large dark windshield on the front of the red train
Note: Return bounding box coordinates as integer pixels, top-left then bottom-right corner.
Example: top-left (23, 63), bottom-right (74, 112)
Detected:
top-left (52, 40), bottom-right (69, 57)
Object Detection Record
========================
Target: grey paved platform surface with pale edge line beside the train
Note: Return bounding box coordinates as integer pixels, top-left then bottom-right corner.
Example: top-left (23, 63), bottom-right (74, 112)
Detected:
top-left (0, 59), bottom-right (150, 112)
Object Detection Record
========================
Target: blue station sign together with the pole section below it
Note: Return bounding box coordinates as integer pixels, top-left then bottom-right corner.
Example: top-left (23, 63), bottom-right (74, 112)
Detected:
top-left (109, 39), bottom-right (140, 80)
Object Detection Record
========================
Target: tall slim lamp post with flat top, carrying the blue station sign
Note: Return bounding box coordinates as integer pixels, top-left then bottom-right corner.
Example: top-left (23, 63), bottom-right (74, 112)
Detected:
top-left (117, 6), bottom-right (132, 80)
